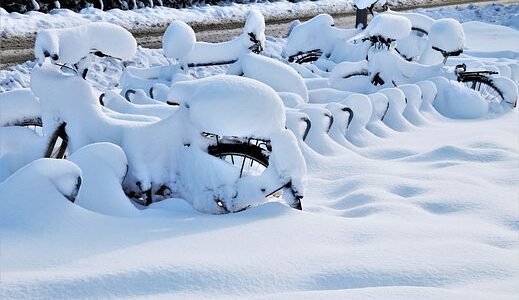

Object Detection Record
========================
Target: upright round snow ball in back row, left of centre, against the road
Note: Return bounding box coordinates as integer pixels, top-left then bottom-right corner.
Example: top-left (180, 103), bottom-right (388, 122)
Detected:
top-left (162, 21), bottom-right (196, 60)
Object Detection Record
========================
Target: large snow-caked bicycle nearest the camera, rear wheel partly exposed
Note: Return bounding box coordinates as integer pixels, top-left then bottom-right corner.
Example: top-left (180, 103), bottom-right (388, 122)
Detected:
top-left (2, 21), bottom-right (306, 213)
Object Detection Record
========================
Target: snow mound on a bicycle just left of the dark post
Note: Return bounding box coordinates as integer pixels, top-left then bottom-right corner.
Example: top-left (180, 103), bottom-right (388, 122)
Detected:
top-left (285, 14), bottom-right (358, 56)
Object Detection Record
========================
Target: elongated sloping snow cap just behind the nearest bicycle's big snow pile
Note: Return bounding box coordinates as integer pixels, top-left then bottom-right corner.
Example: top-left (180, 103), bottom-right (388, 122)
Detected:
top-left (232, 53), bottom-right (308, 102)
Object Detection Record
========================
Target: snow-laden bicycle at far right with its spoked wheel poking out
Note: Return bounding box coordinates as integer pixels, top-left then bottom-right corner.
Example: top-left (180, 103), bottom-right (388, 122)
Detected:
top-left (306, 13), bottom-right (517, 107)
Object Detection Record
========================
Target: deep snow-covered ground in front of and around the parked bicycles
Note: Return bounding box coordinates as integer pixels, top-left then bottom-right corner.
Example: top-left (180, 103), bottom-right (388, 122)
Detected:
top-left (0, 5), bottom-right (519, 299)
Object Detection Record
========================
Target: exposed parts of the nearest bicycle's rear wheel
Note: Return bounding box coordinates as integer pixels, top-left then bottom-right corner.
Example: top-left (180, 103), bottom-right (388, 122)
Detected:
top-left (208, 140), bottom-right (302, 210)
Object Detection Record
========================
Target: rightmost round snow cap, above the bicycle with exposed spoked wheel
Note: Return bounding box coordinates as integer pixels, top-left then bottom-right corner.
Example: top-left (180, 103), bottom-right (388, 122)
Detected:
top-left (429, 19), bottom-right (465, 52)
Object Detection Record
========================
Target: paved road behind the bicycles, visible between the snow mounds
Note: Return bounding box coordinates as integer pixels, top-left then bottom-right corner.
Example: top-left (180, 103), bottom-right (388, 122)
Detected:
top-left (0, 0), bottom-right (518, 69)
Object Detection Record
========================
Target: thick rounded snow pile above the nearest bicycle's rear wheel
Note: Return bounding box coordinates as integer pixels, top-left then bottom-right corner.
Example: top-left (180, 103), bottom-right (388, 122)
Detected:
top-left (168, 75), bottom-right (285, 138)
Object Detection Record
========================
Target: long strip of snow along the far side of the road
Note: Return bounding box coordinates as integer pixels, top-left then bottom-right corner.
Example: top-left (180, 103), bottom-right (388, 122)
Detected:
top-left (0, 0), bottom-right (428, 37)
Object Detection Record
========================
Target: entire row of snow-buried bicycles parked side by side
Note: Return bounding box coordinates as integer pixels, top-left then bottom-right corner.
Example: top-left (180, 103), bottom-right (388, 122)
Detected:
top-left (0, 10), bottom-right (519, 213)
